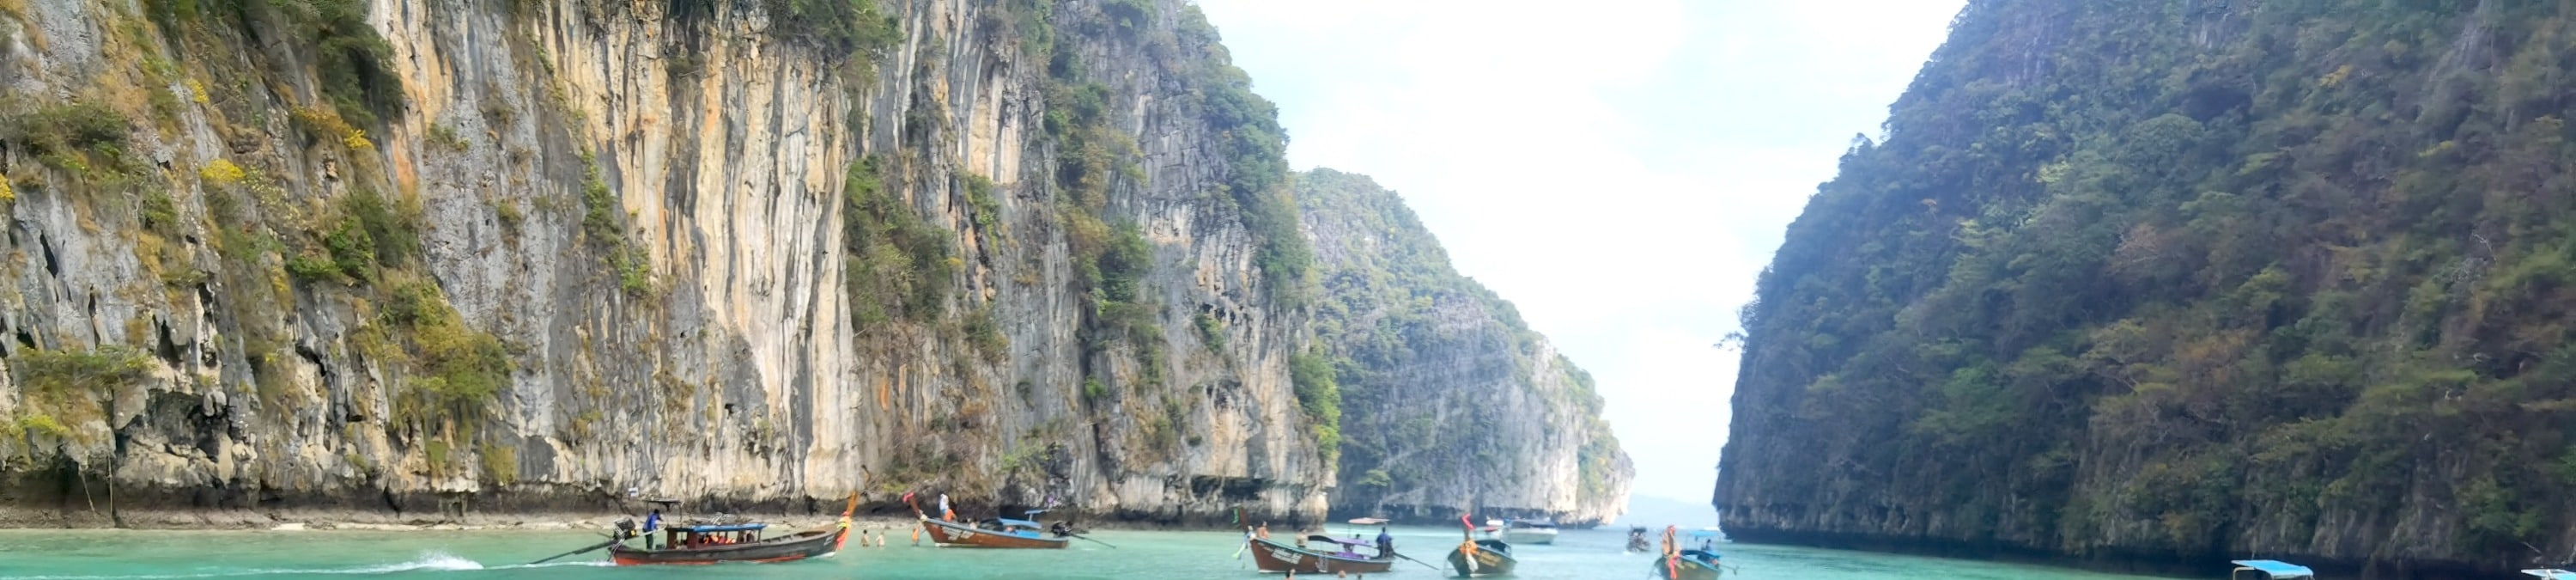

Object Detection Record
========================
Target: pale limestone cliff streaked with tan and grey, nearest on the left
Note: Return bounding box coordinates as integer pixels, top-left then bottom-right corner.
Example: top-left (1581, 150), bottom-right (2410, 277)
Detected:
top-left (0, 0), bottom-right (1334, 526)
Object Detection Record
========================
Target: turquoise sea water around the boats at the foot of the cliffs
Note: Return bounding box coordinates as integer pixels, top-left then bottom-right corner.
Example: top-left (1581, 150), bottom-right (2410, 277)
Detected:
top-left (0, 526), bottom-right (2174, 580)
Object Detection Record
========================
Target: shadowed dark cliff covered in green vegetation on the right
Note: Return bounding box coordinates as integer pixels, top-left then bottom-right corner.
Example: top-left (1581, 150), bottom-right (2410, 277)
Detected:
top-left (1716, 0), bottom-right (2576, 577)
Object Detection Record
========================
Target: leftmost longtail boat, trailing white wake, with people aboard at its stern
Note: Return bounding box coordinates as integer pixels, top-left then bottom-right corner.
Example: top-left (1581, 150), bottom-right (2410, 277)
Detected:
top-left (592, 495), bottom-right (858, 567)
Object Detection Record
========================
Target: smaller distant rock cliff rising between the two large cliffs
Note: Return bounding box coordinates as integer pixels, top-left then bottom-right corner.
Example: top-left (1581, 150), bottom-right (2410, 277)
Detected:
top-left (1296, 170), bottom-right (1636, 526)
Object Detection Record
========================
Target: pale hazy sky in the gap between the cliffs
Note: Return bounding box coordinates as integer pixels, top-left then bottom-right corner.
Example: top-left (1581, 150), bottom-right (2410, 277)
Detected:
top-left (1198, 0), bottom-right (1960, 503)
